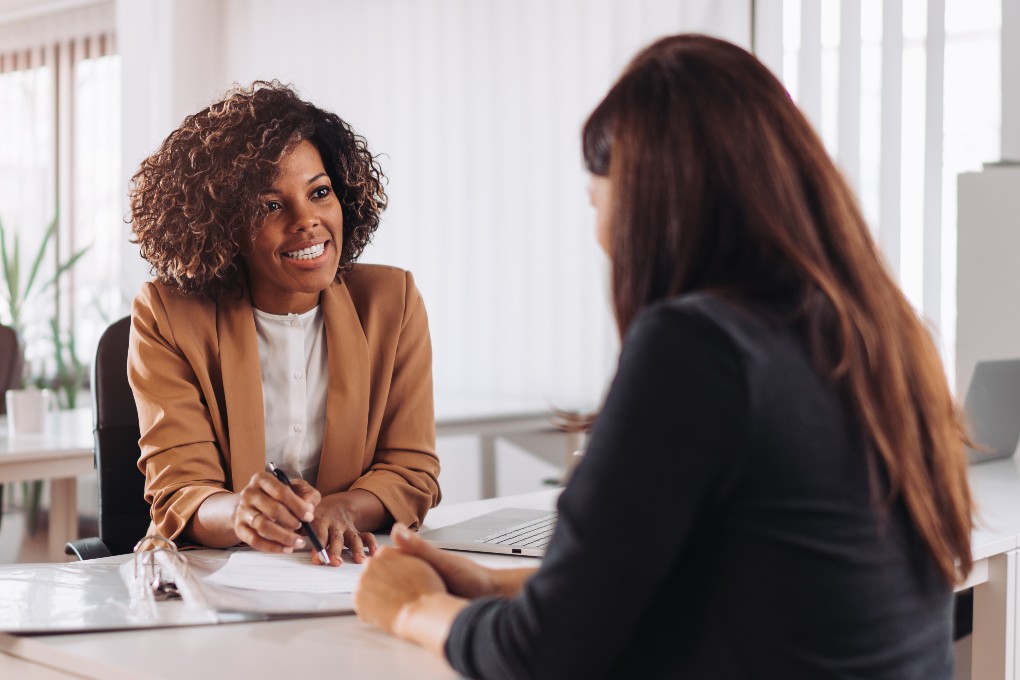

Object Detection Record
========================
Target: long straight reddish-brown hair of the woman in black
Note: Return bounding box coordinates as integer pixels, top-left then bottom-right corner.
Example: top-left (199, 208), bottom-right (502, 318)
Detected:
top-left (582, 35), bottom-right (973, 583)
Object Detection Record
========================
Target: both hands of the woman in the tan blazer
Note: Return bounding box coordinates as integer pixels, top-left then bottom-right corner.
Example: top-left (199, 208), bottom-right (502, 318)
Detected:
top-left (233, 472), bottom-right (376, 566)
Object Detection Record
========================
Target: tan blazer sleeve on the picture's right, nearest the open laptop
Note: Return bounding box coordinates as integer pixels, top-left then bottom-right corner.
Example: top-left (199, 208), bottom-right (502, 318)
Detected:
top-left (351, 272), bottom-right (441, 527)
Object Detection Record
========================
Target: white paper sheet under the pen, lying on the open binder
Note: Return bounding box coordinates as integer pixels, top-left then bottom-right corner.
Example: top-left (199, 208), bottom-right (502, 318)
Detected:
top-left (205, 551), bottom-right (364, 593)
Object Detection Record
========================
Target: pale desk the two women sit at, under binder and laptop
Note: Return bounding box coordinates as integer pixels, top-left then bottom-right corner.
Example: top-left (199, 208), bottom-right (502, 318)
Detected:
top-left (0, 460), bottom-right (1020, 680)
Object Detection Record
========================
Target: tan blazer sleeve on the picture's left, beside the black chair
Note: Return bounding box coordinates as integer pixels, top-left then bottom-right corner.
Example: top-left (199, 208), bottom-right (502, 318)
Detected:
top-left (128, 283), bottom-right (227, 538)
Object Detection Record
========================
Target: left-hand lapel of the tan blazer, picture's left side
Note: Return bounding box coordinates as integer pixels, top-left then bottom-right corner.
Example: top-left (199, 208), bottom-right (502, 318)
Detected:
top-left (216, 291), bottom-right (265, 491)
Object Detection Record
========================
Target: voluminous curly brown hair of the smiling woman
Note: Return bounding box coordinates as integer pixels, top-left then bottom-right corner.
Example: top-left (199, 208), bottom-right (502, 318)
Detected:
top-left (130, 81), bottom-right (387, 299)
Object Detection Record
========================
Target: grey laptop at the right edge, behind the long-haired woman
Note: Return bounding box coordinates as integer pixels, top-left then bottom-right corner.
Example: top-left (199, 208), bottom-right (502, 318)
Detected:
top-left (964, 359), bottom-right (1020, 463)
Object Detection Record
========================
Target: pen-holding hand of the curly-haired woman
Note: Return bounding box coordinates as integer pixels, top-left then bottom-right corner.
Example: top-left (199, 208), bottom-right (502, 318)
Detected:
top-left (233, 471), bottom-right (322, 553)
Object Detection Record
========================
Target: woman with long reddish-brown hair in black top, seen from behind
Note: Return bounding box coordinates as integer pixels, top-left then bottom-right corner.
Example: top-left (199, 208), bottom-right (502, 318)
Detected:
top-left (356, 36), bottom-right (972, 679)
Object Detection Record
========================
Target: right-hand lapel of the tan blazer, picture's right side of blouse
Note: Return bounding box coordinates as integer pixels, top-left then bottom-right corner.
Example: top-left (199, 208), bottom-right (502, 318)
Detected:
top-left (316, 283), bottom-right (370, 493)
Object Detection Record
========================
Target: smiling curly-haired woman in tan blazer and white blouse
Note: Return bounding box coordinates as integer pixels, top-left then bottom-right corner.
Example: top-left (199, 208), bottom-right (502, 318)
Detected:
top-left (129, 82), bottom-right (440, 565)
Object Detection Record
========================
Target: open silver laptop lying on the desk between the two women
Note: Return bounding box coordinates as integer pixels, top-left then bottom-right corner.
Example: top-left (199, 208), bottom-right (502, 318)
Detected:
top-left (418, 508), bottom-right (556, 558)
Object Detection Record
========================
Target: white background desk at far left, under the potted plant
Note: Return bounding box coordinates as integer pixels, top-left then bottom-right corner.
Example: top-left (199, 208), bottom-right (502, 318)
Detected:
top-left (0, 409), bottom-right (95, 562)
